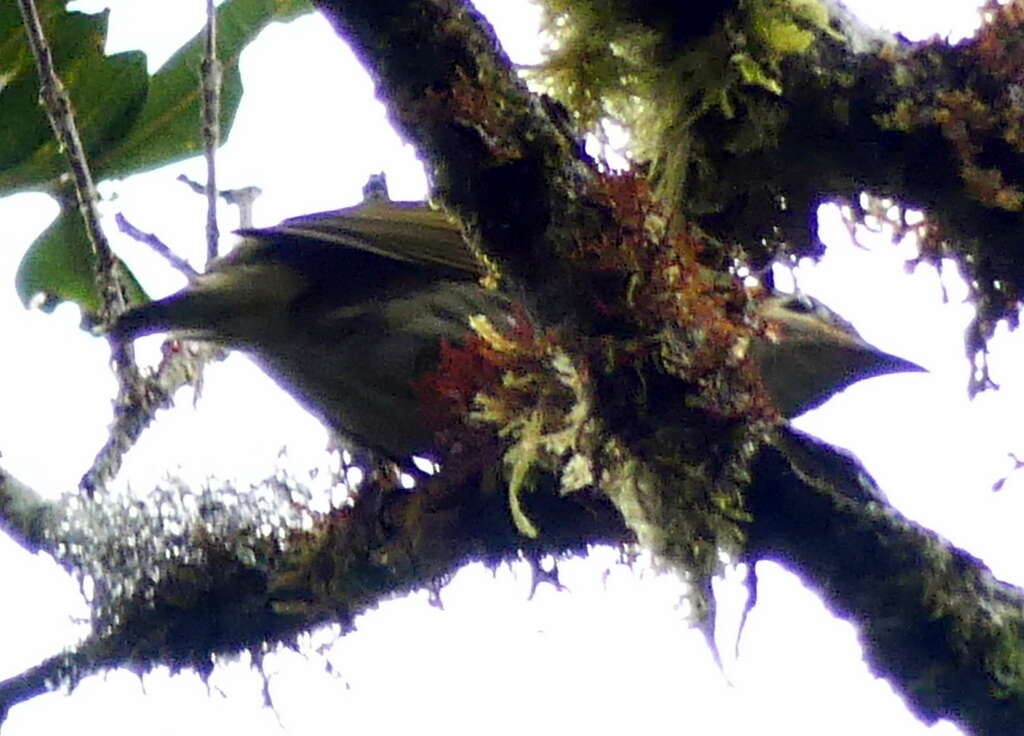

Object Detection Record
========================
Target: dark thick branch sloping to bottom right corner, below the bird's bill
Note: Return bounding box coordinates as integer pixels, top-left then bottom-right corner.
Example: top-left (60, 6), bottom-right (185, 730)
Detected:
top-left (749, 425), bottom-right (1024, 736)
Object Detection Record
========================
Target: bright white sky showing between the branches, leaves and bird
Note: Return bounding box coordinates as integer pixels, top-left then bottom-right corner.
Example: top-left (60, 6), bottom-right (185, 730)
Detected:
top-left (0, 0), bottom-right (1024, 736)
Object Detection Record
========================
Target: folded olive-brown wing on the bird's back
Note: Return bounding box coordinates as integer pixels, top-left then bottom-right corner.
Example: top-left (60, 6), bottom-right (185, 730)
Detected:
top-left (239, 202), bottom-right (484, 276)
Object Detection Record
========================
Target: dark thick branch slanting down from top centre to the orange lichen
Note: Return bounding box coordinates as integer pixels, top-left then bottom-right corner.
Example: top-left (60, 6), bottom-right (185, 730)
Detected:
top-left (314, 0), bottom-right (606, 333)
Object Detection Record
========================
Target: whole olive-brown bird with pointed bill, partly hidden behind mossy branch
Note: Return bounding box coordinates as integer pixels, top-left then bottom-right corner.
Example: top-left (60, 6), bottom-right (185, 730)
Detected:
top-left (110, 193), bottom-right (923, 461)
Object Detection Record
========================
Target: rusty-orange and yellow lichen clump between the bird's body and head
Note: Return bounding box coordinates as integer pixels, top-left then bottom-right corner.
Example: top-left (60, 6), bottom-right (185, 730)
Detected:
top-left (417, 173), bottom-right (771, 489)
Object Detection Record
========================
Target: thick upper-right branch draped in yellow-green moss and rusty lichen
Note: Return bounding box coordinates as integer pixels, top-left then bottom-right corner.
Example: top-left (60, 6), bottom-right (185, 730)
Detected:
top-left (543, 0), bottom-right (1024, 368)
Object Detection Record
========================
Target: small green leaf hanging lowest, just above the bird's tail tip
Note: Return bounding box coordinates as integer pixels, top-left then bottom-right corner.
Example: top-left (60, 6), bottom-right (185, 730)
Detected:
top-left (14, 207), bottom-right (147, 315)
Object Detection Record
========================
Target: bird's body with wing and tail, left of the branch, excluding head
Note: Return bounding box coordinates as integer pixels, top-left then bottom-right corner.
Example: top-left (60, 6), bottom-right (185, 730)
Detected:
top-left (113, 203), bottom-right (511, 459)
